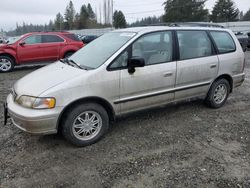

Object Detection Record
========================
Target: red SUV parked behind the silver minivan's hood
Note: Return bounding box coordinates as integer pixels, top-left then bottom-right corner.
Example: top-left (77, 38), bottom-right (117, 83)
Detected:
top-left (0, 32), bottom-right (84, 72)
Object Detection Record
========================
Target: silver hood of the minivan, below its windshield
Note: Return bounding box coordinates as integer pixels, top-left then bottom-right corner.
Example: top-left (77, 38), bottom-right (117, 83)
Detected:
top-left (14, 62), bottom-right (87, 97)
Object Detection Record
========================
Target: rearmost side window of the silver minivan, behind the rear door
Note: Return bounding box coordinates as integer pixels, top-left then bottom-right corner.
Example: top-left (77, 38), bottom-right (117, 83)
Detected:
top-left (210, 31), bottom-right (236, 54)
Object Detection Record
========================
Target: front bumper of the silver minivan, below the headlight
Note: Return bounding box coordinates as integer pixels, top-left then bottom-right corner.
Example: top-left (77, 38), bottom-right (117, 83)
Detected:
top-left (7, 94), bottom-right (62, 134)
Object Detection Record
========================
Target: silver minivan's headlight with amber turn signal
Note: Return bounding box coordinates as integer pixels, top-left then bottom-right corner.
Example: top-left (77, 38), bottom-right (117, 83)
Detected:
top-left (17, 95), bottom-right (56, 109)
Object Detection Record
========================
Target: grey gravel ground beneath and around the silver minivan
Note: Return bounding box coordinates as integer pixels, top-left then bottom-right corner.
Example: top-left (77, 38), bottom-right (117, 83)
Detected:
top-left (0, 52), bottom-right (250, 188)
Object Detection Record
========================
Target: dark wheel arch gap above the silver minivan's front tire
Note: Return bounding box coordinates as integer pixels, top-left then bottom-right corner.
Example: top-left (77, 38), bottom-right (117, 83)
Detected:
top-left (57, 97), bottom-right (115, 131)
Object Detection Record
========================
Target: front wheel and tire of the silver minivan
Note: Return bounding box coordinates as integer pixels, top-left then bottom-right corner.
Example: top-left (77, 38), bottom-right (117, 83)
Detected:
top-left (62, 103), bottom-right (109, 147)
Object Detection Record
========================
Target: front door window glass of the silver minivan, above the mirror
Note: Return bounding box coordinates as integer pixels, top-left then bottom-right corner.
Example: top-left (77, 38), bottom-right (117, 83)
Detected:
top-left (132, 31), bottom-right (173, 65)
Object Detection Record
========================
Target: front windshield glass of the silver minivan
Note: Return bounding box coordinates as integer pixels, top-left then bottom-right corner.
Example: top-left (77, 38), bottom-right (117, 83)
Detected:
top-left (70, 32), bottom-right (136, 69)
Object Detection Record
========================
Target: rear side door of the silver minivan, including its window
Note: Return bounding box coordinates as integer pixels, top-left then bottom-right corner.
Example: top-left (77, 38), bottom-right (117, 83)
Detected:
top-left (175, 30), bottom-right (219, 100)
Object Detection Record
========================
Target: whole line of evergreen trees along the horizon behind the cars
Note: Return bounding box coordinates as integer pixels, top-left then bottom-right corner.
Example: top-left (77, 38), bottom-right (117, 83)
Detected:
top-left (4, 0), bottom-right (250, 36)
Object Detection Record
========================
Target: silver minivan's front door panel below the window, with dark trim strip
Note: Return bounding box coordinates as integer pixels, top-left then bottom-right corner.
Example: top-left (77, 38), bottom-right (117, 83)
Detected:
top-left (116, 62), bottom-right (176, 114)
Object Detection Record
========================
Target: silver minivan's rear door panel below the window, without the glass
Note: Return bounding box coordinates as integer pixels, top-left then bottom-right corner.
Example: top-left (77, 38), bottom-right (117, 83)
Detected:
top-left (175, 56), bottom-right (219, 100)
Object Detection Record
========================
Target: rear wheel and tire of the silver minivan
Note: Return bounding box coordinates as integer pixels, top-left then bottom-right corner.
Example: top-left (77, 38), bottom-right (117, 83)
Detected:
top-left (205, 79), bottom-right (230, 108)
